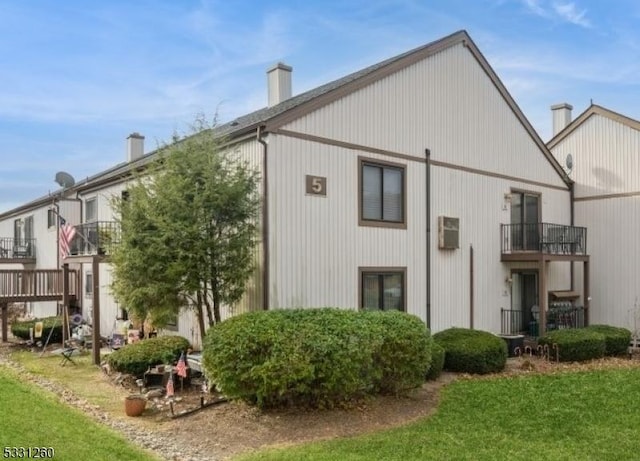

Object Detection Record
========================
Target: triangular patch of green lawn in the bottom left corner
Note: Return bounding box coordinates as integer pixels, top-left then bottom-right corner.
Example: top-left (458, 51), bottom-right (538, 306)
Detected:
top-left (0, 366), bottom-right (156, 461)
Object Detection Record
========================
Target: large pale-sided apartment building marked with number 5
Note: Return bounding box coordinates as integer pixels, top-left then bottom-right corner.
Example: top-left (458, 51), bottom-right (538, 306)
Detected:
top-left (0, 31), bottom-right (589, 343)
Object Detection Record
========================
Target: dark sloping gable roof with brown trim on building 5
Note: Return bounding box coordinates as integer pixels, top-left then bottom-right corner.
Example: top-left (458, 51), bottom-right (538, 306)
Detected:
top-left (0, 30), bottom-right (572, 219)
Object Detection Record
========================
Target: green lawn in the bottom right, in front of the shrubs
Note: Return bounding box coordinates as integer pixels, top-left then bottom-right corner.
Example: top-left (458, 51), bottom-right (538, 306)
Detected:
top-left (238, 369), bottom-right (640, 461)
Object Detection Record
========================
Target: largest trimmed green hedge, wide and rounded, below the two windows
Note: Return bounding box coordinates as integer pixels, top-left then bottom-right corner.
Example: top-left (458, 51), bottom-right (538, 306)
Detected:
top-left (203, 308), bottom-right (431, 408)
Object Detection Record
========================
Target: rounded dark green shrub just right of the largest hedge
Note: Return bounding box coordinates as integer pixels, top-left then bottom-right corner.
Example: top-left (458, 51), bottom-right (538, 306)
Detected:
top-left (433, 328), bottom-right (507, 374)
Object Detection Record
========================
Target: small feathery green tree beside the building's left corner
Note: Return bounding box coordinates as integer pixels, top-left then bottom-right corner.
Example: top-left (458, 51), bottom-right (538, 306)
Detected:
top-left (112, 119), bottom-right (260, 336)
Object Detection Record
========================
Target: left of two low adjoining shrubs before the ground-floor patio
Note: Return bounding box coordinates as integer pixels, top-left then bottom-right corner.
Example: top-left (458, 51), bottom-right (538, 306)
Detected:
top-left (538, 328), bottom-right (606, 362)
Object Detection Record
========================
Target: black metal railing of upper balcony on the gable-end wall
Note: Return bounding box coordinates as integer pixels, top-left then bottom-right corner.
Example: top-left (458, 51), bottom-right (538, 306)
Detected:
top-left (500, 223), bottom-right (587, 255)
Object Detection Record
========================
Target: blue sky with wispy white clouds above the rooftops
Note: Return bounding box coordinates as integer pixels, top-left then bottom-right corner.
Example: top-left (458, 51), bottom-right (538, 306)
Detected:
top-left (0, 0), bottom-right (640, 212)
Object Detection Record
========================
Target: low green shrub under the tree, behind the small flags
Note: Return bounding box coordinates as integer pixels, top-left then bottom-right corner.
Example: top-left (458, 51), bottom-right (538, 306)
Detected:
top-left (107, 336), bottom-right (189, 377)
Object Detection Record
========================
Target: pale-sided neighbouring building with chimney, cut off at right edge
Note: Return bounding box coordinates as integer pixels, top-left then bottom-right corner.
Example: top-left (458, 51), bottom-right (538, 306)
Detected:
top-left (547, 104), bottom-right (640, 331)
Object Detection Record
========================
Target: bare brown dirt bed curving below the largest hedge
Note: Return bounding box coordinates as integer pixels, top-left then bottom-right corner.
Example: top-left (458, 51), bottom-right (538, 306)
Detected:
top-left (150, 373), bottom-right (455, 458)
